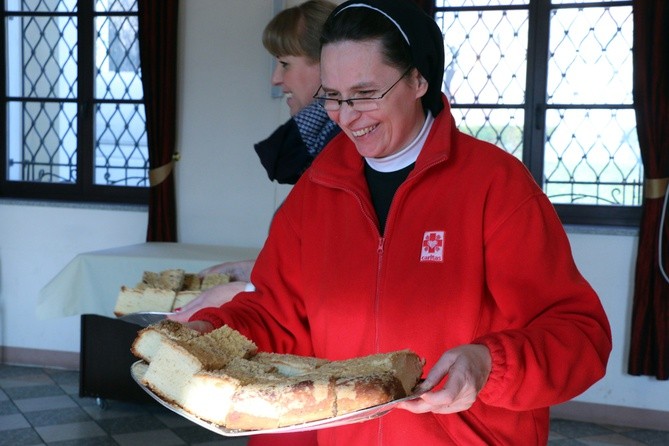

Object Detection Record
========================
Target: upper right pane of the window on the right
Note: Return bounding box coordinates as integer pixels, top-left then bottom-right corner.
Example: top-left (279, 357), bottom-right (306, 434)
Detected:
top-left (547, 6), bottom-right (633, 104)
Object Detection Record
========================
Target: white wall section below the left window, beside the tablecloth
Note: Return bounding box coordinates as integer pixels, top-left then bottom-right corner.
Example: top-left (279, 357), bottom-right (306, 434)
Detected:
top-left (0, 202), bottom-right (147, 351)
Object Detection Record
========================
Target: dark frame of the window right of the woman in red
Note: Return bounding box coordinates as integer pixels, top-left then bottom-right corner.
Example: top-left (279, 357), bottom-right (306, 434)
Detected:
top-left (432, 0), bottom-right (642, 226)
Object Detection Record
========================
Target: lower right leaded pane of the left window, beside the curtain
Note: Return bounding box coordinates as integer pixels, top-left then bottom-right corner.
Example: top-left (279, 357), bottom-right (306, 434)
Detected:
top-left (95, 104), bottom-right (149, 187)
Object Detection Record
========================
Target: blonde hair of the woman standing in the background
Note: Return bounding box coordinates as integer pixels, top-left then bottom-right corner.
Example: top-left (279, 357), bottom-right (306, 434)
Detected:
top-left (262, 0), bottom-right (337, 63)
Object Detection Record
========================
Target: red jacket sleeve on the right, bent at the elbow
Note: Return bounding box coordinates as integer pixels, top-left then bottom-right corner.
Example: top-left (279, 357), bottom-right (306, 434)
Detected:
top-left (474, 192), bottom-right (611, 410)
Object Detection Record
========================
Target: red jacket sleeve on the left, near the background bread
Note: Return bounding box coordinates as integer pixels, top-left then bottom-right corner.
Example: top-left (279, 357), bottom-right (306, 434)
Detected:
top-left (190, 197), bottom-right (314, 356)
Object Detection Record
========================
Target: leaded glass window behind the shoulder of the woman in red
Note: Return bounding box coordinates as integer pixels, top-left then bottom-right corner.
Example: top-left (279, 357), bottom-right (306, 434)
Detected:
top-left (435, 0), bottom-right (643, 224)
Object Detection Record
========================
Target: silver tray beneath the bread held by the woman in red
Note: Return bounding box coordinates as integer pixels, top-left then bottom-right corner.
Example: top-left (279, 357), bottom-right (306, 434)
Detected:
top-left (130, 360), bottom-right (421, 437)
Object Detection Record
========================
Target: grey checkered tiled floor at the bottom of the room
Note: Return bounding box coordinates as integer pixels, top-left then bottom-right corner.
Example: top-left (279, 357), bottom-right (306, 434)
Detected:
top-left (0, 365), bottom-right (669, 446)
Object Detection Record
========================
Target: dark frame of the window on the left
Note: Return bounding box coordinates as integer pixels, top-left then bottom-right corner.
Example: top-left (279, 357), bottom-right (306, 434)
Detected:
top-left (0, 0), bottom-right (149, 204)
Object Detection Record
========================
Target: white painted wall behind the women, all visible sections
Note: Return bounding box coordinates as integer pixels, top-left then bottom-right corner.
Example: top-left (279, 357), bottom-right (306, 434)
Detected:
top-left (0, 0), bottom-right (669, 411)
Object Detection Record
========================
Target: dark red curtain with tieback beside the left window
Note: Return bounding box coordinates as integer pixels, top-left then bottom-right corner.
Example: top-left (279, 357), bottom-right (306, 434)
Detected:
top-left (137, 0), bottom-right (179, 242)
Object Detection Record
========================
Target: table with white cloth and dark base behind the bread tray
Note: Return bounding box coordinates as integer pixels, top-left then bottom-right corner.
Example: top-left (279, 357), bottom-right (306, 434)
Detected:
top-left (37, 242), bottom-right (259, 405)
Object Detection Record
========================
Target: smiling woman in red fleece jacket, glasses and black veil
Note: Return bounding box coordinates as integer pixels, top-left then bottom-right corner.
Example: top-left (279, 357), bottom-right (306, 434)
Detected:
top-left (185, 0), bottom-right (611, 446)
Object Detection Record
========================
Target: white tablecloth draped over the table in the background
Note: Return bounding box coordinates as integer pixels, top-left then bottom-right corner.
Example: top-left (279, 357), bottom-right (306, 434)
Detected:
top-left (37, 242), bottom-right (259, 319)
